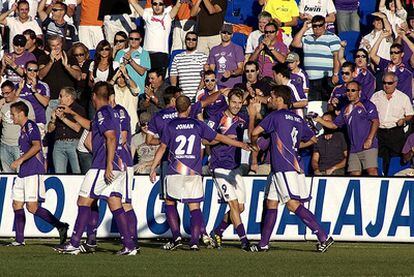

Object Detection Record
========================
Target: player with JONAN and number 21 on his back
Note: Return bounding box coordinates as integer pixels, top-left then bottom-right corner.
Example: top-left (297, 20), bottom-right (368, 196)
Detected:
top-left (150, 96), bottom-right (250, 250)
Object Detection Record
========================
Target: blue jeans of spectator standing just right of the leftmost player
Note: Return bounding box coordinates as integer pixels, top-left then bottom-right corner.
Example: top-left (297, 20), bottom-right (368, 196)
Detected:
top-left (53, 139), bottom-right (81, 174)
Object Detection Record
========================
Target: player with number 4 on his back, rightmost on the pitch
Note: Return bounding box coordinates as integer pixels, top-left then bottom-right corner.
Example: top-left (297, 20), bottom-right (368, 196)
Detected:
top-left (251, 86), bottom-right (333, 252)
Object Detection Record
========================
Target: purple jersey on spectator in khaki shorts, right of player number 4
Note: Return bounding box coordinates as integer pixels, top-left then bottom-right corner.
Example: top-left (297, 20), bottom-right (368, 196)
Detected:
top-left (334, 101), bottom-right (378, 153)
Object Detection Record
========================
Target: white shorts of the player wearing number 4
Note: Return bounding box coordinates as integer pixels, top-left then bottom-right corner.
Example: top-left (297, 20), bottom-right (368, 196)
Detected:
top-left (265, 171), bottom-right (311, 203)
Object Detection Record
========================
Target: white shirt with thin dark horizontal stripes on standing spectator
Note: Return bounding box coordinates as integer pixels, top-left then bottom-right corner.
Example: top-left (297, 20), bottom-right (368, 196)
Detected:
top-left (170, 51), bottom-right (207, 99)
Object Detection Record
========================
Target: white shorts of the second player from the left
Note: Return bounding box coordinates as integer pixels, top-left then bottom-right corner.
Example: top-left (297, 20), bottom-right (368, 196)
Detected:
top-left (79, 168), bottom-right (127, 199)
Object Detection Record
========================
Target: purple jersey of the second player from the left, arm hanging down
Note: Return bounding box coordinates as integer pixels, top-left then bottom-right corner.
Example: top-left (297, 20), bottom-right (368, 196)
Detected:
top-left (91, 105), bottom-right (124, 171)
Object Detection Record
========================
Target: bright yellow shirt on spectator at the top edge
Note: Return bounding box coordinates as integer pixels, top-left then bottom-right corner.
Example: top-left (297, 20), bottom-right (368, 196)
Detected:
top-left (264, 0), bottom-right (299, 35)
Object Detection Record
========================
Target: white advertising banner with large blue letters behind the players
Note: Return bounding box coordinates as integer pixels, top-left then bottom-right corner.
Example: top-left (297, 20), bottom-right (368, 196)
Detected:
top-left (0, 175), bottom-right (414, 242)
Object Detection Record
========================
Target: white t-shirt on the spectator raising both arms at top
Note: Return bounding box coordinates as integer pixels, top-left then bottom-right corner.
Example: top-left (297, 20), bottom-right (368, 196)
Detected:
top-left (142, 6), bottom-right (172, 54)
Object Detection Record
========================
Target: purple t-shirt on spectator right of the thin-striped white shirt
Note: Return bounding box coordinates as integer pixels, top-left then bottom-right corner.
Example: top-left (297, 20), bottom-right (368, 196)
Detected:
top-left (207, 42), bottom-right (244, 88)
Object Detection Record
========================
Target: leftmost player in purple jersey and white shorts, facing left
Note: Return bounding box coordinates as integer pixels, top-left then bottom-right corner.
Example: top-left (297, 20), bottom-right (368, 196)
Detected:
top-left (9, 101), bottom-right (69, 246)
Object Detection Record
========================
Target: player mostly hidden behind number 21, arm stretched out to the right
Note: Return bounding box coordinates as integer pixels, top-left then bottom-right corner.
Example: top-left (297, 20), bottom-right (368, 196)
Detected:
top-left (146, 86), bottom-right (228, 250)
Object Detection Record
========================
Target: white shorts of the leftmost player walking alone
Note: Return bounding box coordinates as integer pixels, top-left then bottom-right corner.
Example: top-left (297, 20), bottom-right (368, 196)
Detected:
top-left (12, 175), bottom-right (46, 202)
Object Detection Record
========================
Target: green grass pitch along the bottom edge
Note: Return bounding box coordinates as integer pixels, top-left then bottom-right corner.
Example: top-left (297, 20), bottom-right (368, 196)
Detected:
top-left (0, 240), bottom-right (414, 276)
